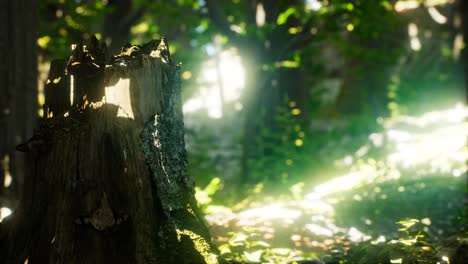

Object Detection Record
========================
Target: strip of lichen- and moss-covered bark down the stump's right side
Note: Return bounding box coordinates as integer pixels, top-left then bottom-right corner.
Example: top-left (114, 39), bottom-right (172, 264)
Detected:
top-left (142, 66), bottom-right (222, 263)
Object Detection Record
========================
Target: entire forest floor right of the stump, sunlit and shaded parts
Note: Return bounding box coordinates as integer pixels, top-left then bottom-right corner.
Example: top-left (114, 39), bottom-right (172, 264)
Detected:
top-left (204, 104), bottom-right (468, 263)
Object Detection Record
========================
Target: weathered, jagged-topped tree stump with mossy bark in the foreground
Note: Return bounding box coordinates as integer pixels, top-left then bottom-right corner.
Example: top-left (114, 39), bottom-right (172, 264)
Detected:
top-left (0, 39), bottom-right (222, 264)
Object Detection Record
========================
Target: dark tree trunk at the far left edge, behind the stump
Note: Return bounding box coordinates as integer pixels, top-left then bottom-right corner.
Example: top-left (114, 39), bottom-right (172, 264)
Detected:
top-left (0, 0), bottom-right (38, 208)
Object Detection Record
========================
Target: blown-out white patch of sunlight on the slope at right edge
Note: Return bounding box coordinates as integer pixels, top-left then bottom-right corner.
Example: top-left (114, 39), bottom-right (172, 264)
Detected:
top-left (387, 104), bottom-right (468, 170)
